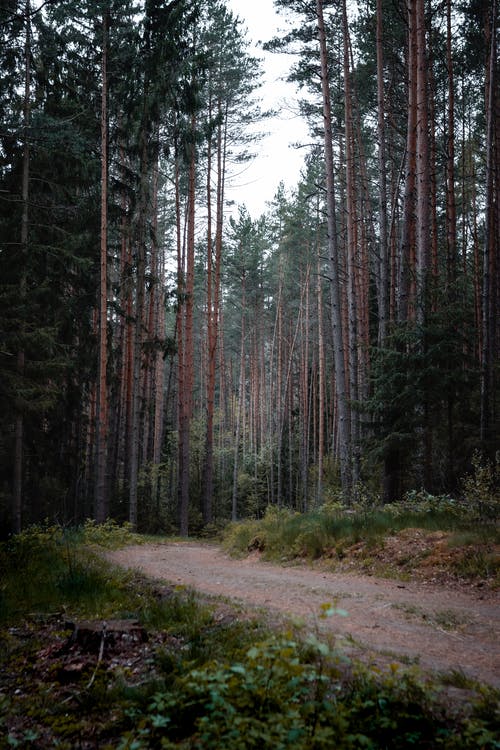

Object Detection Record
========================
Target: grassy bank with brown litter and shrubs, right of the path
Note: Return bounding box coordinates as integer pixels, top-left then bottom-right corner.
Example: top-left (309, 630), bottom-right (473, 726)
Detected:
top-left (223, 472), bottom-right (500, 588)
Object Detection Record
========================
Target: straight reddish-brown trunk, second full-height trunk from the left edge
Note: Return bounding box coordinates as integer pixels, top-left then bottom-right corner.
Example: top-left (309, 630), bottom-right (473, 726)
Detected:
top-left (95, 9), bottom-right (109, 523)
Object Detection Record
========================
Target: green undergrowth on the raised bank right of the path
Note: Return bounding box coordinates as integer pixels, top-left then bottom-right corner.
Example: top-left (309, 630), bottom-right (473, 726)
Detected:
top-left (222, 492), bottom-right (500, 583)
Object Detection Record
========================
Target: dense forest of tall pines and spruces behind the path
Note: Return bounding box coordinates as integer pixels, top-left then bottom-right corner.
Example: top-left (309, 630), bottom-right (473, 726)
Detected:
top-left (0, 0), bottom-right (500, 537)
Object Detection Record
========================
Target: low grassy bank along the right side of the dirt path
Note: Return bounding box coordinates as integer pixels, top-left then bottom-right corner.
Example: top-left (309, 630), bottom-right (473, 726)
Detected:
top-left (223, 504), bottom-right (500, 585)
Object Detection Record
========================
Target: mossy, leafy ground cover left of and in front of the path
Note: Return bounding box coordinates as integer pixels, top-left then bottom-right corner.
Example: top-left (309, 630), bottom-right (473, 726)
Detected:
top-left (0, 524), bottom-right (500, 750)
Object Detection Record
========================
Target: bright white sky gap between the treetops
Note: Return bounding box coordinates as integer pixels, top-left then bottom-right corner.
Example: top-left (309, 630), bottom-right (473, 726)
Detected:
top-left (226, 0), bottom-right (308, 218)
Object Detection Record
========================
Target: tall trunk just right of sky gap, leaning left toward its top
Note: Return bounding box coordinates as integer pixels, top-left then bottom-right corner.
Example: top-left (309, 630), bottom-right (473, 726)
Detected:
top-left (316, 0), bottom-right (352, 491)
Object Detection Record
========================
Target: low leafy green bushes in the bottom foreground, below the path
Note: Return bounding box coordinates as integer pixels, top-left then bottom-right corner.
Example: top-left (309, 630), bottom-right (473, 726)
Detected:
top-left (119, 637), bottom-right (498, 750)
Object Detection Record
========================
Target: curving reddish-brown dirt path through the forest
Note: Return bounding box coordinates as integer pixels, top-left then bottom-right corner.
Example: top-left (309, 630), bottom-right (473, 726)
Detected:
top-left (108, 542), bottom-right (500, 687)
